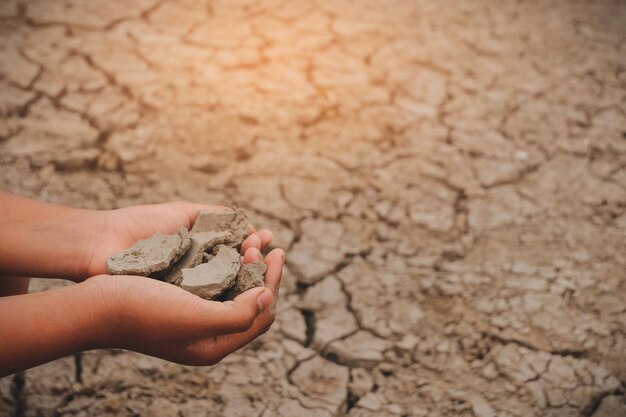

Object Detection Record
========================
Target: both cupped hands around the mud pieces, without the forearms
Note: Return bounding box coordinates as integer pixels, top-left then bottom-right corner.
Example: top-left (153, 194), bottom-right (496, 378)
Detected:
top-left (78, 203), bottom-right (285, 365)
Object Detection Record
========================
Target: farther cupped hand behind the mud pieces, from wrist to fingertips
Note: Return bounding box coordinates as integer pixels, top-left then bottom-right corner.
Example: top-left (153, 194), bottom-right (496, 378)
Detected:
top-left (83, 202), bottom-right (272, 279)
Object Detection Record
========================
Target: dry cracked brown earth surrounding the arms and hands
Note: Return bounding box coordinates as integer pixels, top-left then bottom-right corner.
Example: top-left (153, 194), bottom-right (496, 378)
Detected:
top-left (0, 0), bottom-right (626, 417)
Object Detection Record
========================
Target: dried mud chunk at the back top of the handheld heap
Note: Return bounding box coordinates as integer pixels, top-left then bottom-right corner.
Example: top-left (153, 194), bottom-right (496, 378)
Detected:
top-left (191, 209), bottom-right (248, 247)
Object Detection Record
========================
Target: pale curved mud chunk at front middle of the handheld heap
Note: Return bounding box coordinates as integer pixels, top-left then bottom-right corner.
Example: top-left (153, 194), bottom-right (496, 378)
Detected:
top-left (180, 245), bottom-right (241, 300)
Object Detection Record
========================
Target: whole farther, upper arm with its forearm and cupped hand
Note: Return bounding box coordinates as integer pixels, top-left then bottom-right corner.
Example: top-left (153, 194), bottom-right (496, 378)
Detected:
top-left (0, 191), bottom-right (272, 282)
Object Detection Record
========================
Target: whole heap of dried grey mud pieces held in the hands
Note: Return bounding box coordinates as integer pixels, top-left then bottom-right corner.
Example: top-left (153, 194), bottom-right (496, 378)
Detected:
top-left (107, 209), bottom-right (267, 300)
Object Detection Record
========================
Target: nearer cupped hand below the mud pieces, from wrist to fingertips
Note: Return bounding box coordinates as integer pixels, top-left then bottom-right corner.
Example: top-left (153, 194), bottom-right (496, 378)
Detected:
top-left (81, 247), bottom-right (285, 365)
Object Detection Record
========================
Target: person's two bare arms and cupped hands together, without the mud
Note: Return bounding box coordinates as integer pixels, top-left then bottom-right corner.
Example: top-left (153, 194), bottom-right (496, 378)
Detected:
top-left (0, 191), bottom-right (284, 377)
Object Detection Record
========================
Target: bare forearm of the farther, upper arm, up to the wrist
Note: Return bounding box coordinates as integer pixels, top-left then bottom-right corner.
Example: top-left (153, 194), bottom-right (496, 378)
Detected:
top-left (0, 191), bottom-right (99, 280)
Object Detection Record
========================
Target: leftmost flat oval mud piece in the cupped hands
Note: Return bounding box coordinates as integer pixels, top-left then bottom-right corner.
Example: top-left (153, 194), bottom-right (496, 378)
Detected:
top-left (107, 227), bottom-right (191, 277)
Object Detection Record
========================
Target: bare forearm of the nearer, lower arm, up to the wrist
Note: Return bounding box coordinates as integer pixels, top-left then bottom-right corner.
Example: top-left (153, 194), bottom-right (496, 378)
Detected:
top-left (0, 283), bottom-right (104, 377)
